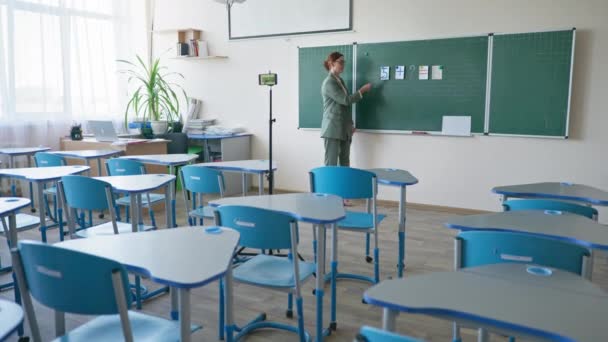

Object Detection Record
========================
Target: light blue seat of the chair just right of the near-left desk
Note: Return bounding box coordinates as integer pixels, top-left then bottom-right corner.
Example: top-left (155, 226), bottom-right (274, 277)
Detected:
top-left (233, 254), bottom-right (315, 288)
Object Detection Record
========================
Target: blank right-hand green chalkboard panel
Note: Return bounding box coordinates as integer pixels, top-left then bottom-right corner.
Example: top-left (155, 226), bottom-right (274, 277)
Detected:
top-left (490, 30), bottom-right (574, 137)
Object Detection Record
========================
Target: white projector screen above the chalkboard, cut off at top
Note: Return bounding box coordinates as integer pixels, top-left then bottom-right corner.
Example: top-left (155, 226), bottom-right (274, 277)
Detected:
top-left (228, 0), bottom-right (352, 39)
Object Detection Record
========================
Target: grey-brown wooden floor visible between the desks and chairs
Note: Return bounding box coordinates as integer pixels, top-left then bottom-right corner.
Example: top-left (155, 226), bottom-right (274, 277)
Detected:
top-left (0, 191), bottom-right (608, 341)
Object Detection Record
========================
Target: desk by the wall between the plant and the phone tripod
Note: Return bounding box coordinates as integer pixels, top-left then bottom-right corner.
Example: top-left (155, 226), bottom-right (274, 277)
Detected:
top-left (188, 133), bottom-right (251, 195)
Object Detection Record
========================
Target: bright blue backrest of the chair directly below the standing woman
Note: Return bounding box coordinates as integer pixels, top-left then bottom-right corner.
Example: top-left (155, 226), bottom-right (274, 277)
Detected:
top-left (309, 166), bottom-right (377, 199)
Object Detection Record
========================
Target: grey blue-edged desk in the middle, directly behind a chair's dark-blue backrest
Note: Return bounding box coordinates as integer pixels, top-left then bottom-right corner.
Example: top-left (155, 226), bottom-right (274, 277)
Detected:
top-left (210, 193), bottom-right (346, 341)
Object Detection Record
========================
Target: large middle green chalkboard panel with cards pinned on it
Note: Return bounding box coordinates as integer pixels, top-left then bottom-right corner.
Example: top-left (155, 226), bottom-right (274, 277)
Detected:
top-left (356, 36), bottom-right (488, 132)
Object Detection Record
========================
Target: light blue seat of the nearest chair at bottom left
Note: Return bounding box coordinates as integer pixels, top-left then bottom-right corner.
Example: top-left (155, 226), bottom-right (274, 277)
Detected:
top-left (53, 311), bottom-right (200, 342)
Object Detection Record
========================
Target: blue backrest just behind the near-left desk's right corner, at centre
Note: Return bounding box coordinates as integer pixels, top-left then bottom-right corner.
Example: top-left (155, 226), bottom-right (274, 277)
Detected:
top-left (215, 205), bottom-right (297, 249)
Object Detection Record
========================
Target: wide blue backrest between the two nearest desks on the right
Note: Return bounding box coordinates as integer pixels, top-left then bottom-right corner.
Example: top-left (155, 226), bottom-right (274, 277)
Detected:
top-left (454, 231), bottom-right (591, 275)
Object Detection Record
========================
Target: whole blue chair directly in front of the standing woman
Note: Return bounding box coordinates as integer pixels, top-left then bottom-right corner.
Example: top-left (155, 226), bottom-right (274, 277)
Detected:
top-left (309, 166), bottom-right (386, 284)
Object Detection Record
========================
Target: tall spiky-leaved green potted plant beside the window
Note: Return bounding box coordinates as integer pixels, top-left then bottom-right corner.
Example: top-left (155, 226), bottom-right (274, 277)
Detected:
top-left (118, 56), bottom-right (188, 136)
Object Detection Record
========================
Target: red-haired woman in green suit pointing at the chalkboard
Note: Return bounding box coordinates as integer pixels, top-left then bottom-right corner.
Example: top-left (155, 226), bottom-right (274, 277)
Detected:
top-left (321, 52), bottom-right (372, 166)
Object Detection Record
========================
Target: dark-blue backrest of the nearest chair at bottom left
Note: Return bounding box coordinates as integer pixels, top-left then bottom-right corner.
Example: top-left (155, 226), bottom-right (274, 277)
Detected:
top-left (16, 241), bottom-right (131, 315)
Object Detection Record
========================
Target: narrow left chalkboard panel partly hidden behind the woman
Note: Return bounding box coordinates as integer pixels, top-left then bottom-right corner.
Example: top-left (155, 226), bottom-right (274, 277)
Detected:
top-left (298, 44), bottom-right (353, 128)
